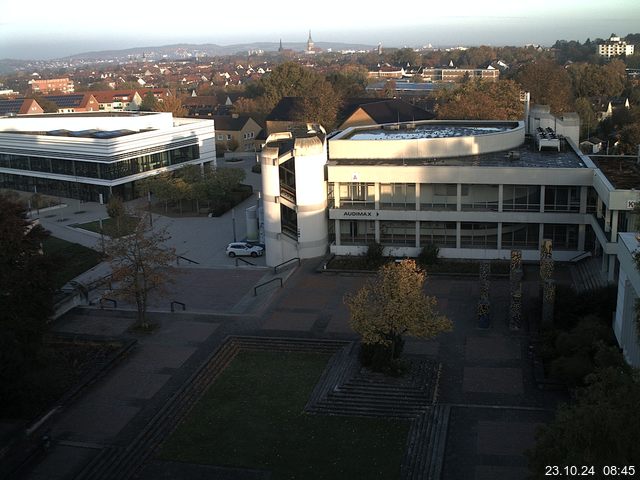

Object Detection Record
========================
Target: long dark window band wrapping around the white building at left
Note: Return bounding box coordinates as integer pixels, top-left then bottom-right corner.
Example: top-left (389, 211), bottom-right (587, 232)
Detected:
top-left (0, 145), bottom-right (200, 180)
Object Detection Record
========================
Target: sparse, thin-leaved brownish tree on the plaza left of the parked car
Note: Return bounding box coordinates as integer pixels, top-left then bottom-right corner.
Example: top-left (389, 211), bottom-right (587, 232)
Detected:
top-left (105, 218), bottom-right (176, 329)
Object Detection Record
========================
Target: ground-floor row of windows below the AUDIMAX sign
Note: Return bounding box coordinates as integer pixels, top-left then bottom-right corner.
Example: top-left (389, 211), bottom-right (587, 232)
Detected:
top-left (340, 220), bottom-right (578, 250)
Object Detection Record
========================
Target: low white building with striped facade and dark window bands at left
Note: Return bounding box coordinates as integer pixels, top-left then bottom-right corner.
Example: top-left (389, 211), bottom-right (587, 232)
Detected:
top-left (0, 112), bottom-right (216, 202)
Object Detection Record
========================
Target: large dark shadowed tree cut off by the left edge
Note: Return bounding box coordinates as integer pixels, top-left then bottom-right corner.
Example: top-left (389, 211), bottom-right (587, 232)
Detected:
top-left (0, 195), bottom-right (54, 405)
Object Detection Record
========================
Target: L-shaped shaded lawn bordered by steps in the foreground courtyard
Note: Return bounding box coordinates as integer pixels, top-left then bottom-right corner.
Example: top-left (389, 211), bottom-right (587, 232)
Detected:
top-left (159, 352), bottom-right (409, 480)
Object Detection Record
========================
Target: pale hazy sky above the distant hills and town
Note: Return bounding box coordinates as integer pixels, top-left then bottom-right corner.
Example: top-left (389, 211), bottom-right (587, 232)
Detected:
top-left (0, 0), bottom-right (640, 60)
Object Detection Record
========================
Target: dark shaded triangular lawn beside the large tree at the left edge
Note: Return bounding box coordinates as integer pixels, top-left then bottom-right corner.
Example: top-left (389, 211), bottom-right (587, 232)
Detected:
top-left (42, 237), bottom-right (102, 288)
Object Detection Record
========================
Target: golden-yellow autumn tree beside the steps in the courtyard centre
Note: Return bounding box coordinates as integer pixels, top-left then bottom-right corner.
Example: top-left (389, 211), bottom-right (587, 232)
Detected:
top-left (345, 260), bottom-right (452, 370)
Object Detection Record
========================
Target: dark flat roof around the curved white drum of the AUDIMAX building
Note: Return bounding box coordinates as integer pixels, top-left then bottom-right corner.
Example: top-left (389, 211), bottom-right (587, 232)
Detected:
top-left (328, 138), bottom-right (588, 168)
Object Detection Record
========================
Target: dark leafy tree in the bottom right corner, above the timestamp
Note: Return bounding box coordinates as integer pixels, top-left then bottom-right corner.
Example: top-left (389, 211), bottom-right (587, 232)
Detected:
top-left (528, 368), bottom-right (640, 472)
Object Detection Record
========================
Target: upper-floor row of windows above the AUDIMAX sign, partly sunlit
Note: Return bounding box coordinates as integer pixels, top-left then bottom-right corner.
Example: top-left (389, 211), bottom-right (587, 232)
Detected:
top-left (328, 183), bottom-right (581, 212)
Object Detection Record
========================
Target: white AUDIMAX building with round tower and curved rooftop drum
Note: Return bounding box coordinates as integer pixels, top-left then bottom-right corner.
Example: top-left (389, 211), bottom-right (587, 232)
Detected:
top-left (260, 108), bottom-right (640, 281)
